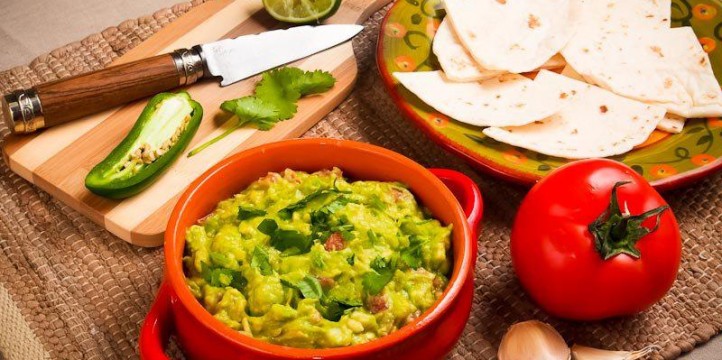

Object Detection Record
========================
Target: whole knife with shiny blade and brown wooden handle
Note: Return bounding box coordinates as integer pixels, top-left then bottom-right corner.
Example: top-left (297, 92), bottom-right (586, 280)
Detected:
top-left (2, 25), bottom-right (363, 134)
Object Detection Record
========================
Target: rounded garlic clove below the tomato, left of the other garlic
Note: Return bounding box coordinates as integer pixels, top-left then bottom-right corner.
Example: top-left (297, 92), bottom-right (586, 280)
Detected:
top-left (497, 320), bottom-right (571, 360)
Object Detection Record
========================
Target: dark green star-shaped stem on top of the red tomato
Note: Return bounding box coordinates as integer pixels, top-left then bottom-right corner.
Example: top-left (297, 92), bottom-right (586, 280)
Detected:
top-left (589, 181), bottom-right (669, 260)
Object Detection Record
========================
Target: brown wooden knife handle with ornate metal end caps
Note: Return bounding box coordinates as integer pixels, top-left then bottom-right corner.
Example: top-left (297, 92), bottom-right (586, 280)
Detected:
top-left (3, 48), bottom-right (204, 133)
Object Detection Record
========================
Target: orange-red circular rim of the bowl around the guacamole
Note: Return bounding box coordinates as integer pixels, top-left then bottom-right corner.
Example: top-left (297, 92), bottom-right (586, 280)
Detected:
top-left (164, 138), bottom-right (476, 358)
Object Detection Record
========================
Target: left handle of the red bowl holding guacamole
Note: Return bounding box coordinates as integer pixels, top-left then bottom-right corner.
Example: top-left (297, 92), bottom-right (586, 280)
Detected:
top-left (138, 281), bottom-right (173, 360)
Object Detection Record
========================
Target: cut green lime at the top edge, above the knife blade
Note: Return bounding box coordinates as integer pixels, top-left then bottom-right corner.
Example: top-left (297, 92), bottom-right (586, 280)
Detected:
top-left (263, 0), bottom-right (341, 24)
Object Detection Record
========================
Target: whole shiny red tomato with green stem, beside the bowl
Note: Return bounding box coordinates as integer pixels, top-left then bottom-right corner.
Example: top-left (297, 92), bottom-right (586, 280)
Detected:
top-left (511, 159), bottom-right (682, 320)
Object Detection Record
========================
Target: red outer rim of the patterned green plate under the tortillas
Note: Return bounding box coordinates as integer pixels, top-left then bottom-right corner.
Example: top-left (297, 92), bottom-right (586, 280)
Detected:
top-left (375, 1), bottom-right (722, 191)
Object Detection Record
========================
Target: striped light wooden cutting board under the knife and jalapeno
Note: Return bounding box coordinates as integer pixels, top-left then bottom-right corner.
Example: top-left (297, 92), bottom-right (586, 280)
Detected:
top-left (3, 0), bottom-right (390, 246)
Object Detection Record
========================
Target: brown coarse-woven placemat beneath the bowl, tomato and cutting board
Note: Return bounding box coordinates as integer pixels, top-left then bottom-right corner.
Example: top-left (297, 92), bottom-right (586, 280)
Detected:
top-left (0, 3), bottom-right (722, 359)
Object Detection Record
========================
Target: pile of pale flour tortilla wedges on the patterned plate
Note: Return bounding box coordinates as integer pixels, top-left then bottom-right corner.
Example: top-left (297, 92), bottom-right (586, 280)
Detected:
top-left (394, 0), bottom-right (722, 159)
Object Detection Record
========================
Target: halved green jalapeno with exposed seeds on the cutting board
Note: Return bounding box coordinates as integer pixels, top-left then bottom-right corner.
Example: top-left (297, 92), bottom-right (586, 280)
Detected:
top-left (85, 92), bottom-right (203, 199)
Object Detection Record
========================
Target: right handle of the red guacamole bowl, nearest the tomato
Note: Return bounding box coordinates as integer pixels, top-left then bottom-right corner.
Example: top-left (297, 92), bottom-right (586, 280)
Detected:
top-left (429, 169), bottom-right (484, 259)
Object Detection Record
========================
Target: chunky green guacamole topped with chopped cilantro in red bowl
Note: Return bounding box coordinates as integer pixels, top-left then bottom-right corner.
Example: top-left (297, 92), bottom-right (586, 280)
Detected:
top-left (183, 168), bottom-right (452, 348)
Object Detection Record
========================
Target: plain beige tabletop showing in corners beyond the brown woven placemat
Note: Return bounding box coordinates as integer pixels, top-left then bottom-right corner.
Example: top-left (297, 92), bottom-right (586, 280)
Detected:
top-left (0, 0), bottom-right (722, 360)
